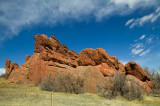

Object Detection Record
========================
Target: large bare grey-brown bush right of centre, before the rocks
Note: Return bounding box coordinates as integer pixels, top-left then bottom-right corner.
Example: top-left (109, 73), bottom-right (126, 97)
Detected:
top-left (97, 71), bottom-right (142, 100)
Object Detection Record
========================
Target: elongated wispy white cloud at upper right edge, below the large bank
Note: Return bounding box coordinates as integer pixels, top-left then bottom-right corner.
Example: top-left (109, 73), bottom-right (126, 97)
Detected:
top-left (125, 7), bottom-right (160, 28)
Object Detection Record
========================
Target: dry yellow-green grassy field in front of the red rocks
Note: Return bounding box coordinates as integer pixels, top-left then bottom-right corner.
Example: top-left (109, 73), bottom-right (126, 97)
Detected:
top-left (0, 79), bottom-right (160, 106)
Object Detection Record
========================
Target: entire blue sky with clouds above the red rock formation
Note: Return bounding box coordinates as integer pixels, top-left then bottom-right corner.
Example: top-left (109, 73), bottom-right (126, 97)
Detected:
top-left (0, 0), bottom-right (160, 73)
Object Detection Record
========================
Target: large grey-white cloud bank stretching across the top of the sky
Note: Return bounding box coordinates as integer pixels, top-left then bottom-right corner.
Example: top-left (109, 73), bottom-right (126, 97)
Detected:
top-left (0, 0), bottom-right (160, 40)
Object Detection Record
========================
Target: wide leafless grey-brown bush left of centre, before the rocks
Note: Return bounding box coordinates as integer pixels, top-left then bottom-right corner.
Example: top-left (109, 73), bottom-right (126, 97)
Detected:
top-left (40, 72), bottom-right (84, 94)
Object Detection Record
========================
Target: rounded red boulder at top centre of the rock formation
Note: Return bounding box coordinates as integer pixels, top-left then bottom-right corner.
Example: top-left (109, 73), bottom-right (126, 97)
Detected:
top-left (77, 48), bottom-right (118, 69)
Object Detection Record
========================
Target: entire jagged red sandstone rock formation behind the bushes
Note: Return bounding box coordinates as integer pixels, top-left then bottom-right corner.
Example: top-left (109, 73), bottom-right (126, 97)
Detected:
top-left (5, 34), bottom-right (152, 92)
